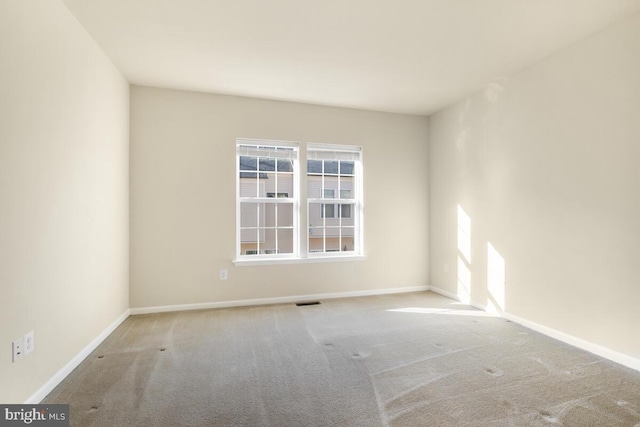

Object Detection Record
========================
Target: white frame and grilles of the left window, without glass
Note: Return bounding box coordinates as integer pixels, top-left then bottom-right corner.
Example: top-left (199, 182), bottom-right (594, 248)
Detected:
top-left (235, 138), bottom-right (300, 261)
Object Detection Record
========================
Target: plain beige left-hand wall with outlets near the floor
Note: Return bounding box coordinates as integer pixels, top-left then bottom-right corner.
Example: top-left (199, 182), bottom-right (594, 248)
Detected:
top-left (0, 0), bottom-right (128, 403)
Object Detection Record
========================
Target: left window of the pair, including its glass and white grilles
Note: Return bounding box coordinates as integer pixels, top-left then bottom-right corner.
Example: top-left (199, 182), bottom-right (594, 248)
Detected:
top-left (236, 140), bottom-right (299, 259)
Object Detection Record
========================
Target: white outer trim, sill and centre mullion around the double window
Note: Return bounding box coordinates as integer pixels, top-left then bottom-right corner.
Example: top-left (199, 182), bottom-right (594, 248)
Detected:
top-left (233, 138), bottom-right (367, 266)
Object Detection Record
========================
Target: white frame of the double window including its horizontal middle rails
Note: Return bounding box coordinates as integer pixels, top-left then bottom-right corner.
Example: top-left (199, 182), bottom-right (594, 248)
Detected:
top-left (233, 138), bottom-right (365, 266)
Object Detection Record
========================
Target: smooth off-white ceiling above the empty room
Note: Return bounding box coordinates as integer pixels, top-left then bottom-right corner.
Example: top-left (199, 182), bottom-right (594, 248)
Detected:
top-left (63, 0), bottom-right (640, 115)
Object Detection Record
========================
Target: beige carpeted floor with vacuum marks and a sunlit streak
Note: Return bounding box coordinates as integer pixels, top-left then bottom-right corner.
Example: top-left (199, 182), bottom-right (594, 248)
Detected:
top-left (43, 292), bottom-right (640, 427)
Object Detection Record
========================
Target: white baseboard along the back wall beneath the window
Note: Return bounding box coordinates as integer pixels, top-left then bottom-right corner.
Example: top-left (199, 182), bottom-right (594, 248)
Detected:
top-left (131, 286), bottom-right (429, 315)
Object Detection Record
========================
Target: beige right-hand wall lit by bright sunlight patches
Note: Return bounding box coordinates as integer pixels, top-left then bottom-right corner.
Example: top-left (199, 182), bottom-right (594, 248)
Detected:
top-left (430, 16), bottom-right (640, 358)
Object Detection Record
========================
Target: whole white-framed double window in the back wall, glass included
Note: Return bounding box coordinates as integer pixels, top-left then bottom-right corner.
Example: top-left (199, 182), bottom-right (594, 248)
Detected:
top-left (236, 139), bottom-right (363, 261)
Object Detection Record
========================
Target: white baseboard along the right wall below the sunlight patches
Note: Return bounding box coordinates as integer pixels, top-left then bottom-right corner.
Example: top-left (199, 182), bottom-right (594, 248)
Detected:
top-left (429, 286), bottom-right (640, 371)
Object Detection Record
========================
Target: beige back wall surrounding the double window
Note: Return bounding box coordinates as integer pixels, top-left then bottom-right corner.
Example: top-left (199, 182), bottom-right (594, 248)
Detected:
top-left (131, 86), bottom-right (428, 307)
